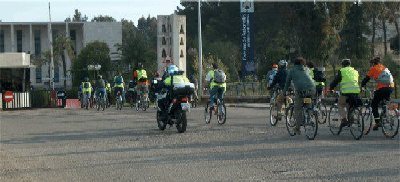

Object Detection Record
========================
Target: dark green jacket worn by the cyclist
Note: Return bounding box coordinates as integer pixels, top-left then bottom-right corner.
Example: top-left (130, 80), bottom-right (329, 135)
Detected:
top-left (283, 65), bottom-right (315, 93)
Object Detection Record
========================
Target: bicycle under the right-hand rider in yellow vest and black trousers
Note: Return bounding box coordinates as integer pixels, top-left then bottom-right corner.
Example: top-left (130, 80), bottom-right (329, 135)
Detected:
top-left (328, 91), bottom-right (364, 140)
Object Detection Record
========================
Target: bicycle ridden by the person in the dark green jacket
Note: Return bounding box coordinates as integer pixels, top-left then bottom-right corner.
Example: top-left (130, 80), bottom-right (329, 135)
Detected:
top-left (285, 91), bottom-right (318, 140)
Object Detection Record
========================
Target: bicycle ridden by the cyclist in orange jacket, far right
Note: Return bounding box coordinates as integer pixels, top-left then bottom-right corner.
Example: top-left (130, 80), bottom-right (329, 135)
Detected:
top-left (363, 89), bottom-right (400, 138)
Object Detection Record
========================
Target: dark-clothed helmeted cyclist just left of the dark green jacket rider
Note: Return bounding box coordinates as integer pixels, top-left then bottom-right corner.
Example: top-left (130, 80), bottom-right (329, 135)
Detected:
top-left (268, 60), bottom-right (288, 115)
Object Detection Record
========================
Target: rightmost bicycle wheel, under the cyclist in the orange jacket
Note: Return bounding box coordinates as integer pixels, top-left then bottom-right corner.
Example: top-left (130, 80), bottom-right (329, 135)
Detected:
top-left (381, 110), bottom-right (400, 138)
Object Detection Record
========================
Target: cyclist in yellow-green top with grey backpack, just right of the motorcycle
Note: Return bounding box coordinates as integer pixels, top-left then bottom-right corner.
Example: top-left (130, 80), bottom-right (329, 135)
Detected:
top-left (206, 63), bottom-right (226, 114)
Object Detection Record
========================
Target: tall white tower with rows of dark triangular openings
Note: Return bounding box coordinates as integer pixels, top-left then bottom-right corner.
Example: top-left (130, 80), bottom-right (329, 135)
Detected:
top-left (157, 14), bottom-right (186, 72)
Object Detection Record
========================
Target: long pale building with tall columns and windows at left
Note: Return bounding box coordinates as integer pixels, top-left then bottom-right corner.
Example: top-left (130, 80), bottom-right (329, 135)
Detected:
top-left (0, 22), bottom-right (122, 88)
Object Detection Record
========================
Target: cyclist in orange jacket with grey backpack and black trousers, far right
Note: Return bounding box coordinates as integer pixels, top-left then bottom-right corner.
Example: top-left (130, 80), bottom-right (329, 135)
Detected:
top-left (361, 57), bottom-right (394, 130)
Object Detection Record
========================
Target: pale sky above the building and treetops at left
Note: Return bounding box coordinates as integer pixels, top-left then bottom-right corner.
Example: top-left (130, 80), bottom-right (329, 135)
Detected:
top-left (0, 0), bottom-right (180, 25)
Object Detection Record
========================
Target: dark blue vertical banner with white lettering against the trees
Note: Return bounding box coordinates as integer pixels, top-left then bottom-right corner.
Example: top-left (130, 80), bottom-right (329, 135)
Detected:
top-left (240, 0), bottom-right (256, 77)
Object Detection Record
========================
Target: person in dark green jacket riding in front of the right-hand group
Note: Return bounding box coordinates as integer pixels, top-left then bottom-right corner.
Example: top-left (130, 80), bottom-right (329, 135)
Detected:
top-left (283, 57), bottom-right (315, 135)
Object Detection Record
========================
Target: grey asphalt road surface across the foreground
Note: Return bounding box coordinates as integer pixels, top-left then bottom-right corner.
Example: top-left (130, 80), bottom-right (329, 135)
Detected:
top-left (0, 107), bottom-right (400, 181)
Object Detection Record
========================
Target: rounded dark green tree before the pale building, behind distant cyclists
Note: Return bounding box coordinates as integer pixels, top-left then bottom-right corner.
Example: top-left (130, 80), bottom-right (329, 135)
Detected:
top-left (72, 41), bottom-right (111, 86)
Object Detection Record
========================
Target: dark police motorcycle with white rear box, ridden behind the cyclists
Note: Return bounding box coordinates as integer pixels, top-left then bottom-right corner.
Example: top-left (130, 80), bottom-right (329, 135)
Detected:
top-left (157, 71), bottom-right (194, 133)
